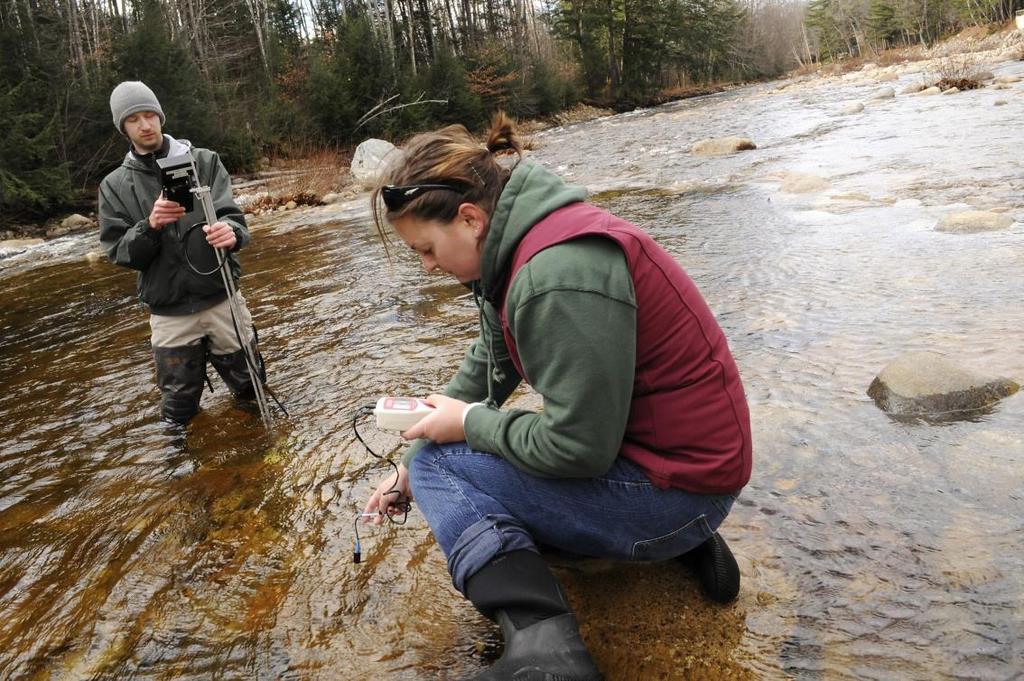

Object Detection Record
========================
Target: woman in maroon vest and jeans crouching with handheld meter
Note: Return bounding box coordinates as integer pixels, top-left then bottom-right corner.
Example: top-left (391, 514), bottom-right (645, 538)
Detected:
top-left (366, 114), bottom-right (752, 681)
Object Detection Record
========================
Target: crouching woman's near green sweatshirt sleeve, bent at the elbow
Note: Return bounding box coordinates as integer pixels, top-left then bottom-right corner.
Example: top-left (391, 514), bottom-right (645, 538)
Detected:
top-left (466, 238), bottom-right (636, 477)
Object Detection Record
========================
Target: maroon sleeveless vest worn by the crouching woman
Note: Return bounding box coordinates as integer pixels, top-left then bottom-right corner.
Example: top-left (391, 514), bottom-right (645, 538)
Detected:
top-left (501, 203), bottom-right (752, 494)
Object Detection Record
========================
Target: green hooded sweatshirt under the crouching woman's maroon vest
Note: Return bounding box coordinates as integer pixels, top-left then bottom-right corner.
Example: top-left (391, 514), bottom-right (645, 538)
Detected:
top-left (402, 162), bottom-right (636, 477)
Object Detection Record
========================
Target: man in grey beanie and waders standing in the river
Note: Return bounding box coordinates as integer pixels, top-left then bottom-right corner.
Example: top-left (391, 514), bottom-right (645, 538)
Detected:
top-left (99, 81), bottom-right (262, 424)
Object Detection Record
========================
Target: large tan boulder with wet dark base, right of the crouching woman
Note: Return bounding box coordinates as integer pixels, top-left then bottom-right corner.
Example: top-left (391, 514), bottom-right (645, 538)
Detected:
top-left (867, 352), bottom-right (1020, 420)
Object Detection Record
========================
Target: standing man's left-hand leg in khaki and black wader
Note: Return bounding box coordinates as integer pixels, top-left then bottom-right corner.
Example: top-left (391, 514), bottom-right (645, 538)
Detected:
top-left (150, 314), bottom-right (206, 424)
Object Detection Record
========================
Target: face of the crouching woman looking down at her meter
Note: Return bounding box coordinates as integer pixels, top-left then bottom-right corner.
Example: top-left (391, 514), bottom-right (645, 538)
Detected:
top-left (391, 203), bottom-right (487, 284)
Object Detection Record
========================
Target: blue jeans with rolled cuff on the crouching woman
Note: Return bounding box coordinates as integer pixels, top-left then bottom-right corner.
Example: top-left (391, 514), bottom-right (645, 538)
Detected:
top-left (410, 442), bottom-right (735, 593)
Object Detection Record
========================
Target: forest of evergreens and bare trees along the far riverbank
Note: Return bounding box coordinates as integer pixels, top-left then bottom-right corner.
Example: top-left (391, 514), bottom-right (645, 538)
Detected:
top-left (0, 0), bottom-right (1024, 226)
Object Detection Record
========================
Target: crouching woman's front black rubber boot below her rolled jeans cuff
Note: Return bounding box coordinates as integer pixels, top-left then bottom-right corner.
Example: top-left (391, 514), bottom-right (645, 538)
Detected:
top-left (466, 550), bottom-right (601, 681)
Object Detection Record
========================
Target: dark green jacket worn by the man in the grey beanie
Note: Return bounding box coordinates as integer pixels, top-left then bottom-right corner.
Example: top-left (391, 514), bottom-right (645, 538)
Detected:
top-left (98, 135), bottom-right (250, 315)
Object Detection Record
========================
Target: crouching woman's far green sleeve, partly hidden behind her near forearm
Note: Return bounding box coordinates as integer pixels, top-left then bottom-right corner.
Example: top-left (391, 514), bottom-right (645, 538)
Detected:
top-left (401, 292), bottom-right (522, 468)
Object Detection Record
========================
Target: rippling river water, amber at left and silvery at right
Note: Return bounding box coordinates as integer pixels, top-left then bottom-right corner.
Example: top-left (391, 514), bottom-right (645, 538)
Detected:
top-left (6, 63), bottom-right (1024, 679)
